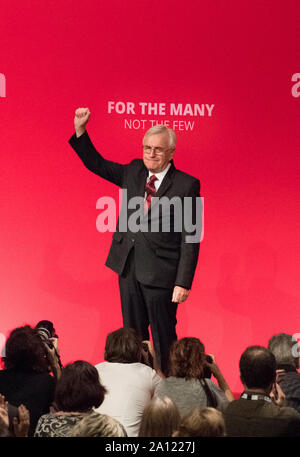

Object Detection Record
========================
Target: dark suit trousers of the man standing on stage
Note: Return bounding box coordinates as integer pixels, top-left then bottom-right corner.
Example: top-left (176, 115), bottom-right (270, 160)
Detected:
top-left (119, 248), bottom-right (178, 375)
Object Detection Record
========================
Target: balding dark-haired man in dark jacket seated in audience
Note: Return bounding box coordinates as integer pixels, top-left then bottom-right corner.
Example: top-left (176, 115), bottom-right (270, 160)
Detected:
top-left (224, 346), bottom-right (300, 437)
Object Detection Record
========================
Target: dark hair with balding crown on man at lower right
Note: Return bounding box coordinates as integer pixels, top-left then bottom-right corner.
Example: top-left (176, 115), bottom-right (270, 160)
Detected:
top-left (240, 346), bottom-right (276, 389)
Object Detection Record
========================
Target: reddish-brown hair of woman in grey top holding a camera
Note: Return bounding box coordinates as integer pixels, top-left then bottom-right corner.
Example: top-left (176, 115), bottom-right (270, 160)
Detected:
top-left (168, 338), bottom-right (205, 379)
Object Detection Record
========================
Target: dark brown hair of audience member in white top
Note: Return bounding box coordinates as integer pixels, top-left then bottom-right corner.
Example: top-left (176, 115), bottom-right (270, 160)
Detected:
top-left (104, 328), bottom-right (142, 363)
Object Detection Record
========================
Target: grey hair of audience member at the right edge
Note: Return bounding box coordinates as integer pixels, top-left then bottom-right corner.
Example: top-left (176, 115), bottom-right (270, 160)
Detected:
top-left (268, 333), bottom-right (299, 368)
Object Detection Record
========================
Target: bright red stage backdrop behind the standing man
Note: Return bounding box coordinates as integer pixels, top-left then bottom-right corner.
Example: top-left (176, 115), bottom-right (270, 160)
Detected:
top-left (0, 0), bottom-right (300, 390)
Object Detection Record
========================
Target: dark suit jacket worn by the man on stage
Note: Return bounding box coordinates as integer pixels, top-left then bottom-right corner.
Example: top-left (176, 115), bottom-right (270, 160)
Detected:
top-left (69, 132), bottom-right (200, 289)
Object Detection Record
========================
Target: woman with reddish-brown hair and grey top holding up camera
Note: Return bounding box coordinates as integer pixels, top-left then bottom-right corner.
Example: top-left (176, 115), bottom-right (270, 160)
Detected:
top-left (156, 338), bottom-right (234, 415)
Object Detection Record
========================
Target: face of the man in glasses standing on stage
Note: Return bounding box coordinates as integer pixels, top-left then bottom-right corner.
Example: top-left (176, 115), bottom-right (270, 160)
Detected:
top-left (143, 132), bottom-right (175, 173)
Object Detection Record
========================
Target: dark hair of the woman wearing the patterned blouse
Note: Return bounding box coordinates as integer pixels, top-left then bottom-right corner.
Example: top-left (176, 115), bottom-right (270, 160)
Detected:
top-left (54, 360), bottom-right (106, 412)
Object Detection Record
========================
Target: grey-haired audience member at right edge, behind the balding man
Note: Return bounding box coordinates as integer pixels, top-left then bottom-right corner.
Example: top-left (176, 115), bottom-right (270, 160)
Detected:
top-left (268, 333), bottom-right (300, 413)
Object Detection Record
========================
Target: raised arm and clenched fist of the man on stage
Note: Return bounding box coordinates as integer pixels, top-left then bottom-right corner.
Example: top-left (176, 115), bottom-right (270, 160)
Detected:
top-left (69, 108), bottom-right (126, 187)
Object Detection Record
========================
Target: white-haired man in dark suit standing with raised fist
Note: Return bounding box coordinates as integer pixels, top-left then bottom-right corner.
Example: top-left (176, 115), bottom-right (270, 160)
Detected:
top-left (69, 108), bottom-right (202, 372)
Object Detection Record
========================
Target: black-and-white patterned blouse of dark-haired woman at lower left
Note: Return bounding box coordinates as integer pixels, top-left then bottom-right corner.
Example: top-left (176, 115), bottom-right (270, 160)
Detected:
top-left (34, 413), bottom-right (86, 437)
